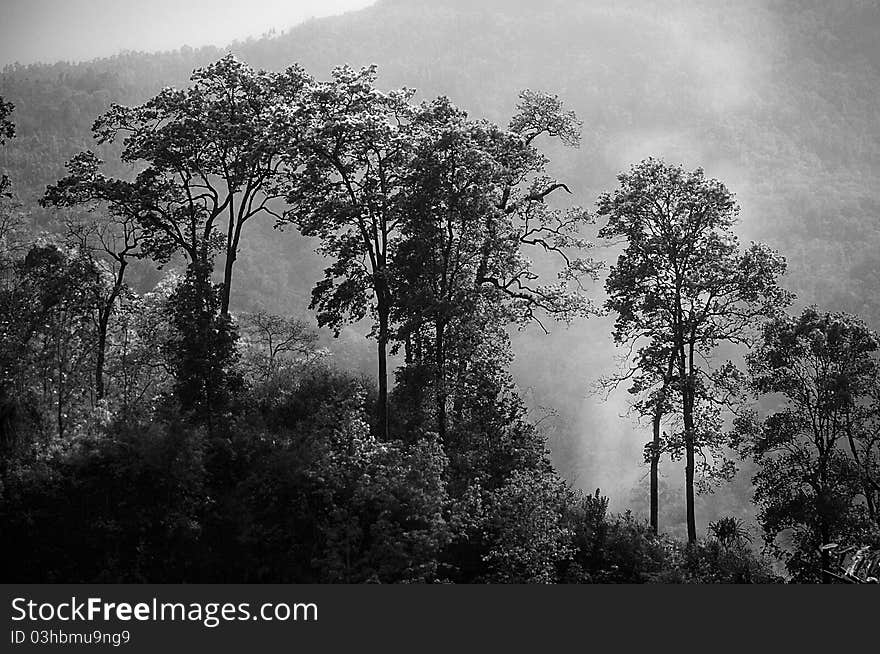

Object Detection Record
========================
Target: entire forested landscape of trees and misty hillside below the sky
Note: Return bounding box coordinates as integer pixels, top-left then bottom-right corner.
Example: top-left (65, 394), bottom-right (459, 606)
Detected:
top-left (0, 0), bottom-right (880, 583)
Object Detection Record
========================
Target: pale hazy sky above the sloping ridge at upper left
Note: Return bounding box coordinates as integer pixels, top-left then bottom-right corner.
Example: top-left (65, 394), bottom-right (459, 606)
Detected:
top-left (0, 0), bottom-right (375, 66)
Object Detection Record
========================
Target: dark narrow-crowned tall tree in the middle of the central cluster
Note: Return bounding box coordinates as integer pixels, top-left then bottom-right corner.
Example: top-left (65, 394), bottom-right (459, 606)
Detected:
top-left (390, 98), bottom-right (500, 445)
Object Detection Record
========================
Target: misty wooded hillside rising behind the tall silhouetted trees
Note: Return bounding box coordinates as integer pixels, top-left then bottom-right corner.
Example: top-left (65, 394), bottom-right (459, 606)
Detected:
top-left (0, 0), bottom-right (880, 532)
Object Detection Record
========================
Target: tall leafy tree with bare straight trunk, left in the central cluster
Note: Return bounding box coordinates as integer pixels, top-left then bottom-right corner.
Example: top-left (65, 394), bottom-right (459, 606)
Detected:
top-left (285, 66), bottom-right (414, 439)
